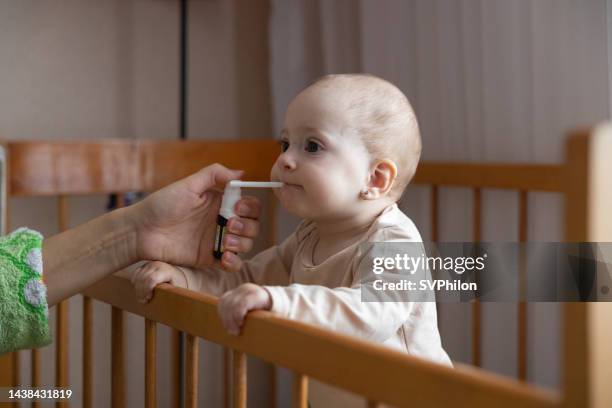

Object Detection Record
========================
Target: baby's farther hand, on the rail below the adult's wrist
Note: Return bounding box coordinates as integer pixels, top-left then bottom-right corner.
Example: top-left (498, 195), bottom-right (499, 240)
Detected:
top-left (131, 261), bottom-right (187, 303)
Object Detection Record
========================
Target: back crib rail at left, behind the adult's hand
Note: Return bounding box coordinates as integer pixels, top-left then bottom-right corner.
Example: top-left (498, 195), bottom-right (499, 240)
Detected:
top-left (7, 139), bottom-right (279, 197)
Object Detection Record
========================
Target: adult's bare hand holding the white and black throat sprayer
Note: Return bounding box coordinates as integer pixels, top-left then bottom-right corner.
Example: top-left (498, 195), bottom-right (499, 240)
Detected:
top-left (128, 164), bottom-right (261, 271)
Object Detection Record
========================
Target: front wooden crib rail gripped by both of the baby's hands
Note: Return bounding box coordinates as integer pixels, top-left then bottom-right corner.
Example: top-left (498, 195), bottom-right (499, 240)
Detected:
top-left (85, 276), bottom-right (559, 408)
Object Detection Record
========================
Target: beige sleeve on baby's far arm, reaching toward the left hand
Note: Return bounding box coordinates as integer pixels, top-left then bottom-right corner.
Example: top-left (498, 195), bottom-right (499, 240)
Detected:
top-left (180, 226), bottom-right (298, 296)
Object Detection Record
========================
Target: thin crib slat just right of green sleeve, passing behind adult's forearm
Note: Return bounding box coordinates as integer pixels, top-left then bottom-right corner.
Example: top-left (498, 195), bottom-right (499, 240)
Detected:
top-left (55, 195), bottom-right (69, 407)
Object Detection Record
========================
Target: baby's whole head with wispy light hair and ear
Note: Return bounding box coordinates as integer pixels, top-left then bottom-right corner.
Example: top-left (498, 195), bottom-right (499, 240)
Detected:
top-left (271, 74), bottom-right (421, 220)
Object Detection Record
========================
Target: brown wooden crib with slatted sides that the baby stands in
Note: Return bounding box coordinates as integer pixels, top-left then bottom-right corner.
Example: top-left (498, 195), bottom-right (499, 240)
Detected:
top-left (0, 128), bottom-right (612, 408)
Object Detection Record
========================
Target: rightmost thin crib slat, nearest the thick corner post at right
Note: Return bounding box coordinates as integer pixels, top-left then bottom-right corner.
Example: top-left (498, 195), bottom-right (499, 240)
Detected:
top-left (518, 190), bottom-right (527, 381)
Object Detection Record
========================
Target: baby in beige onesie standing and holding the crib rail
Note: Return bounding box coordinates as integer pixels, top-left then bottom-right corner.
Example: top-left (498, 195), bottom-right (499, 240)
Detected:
top-left (132, 74), bottom-right (451, 365)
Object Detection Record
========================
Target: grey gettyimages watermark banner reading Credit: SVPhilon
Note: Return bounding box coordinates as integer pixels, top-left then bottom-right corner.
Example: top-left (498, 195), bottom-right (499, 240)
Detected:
top-left (358, 242), bottom-right (612, 302)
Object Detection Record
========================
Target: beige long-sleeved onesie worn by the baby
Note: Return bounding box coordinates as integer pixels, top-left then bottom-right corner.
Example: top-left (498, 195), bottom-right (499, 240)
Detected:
top-left (181, 204), bottom-right (452, 366)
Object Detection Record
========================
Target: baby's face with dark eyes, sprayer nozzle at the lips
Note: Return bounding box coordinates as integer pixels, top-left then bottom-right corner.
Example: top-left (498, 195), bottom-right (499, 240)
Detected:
top-left (271, 88), bottom-right (370, 220)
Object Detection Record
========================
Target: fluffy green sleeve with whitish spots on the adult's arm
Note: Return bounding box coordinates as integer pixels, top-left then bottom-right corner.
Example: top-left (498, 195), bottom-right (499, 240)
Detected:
top-left (0, 228), bottom-right (51, 354)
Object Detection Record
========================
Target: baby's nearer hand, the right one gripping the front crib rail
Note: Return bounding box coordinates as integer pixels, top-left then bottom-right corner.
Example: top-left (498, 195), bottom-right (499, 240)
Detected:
top-left (218, 283), bottom-right (272, 336)
